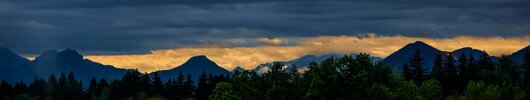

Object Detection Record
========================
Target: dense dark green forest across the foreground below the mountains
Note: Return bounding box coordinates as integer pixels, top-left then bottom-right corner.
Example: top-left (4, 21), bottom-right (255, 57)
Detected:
top-left (0, 50), bottom-right (530, 100)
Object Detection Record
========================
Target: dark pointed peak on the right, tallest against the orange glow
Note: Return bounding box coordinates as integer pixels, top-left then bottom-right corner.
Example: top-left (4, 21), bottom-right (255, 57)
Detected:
top-left (383, 41), bottom-right (447, 73)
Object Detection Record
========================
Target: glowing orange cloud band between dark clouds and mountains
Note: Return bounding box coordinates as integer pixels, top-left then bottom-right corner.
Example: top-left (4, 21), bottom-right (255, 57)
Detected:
top-left (82, 34), bottom-right (530, 72)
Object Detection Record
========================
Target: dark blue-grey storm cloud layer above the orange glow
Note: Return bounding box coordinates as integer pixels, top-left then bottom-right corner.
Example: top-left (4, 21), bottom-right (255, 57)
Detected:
top-left (0, 0), bottom-right (530, 55)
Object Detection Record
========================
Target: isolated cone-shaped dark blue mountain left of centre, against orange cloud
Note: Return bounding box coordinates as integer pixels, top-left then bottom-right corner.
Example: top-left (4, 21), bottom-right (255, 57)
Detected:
top-left (154, 55), bottom-right (230, 82)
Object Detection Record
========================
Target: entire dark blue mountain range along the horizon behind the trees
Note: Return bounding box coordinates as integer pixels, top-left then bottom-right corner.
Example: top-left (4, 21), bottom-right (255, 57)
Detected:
top-left (0, 41), bottom-right (530, 83)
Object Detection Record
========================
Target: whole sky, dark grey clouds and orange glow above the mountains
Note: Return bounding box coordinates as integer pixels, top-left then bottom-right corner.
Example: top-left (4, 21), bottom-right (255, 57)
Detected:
top-left (0, 0), bottom-right (530, 72)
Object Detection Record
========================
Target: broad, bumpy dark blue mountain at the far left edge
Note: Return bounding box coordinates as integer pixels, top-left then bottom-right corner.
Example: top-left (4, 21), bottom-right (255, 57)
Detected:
top-left (0, 48), bottom-right (127, 83)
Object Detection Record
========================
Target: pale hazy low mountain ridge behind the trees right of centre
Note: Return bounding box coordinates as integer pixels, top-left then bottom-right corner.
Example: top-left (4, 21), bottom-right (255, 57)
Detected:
top-left (253, 54), bottom-right (382, 74)
